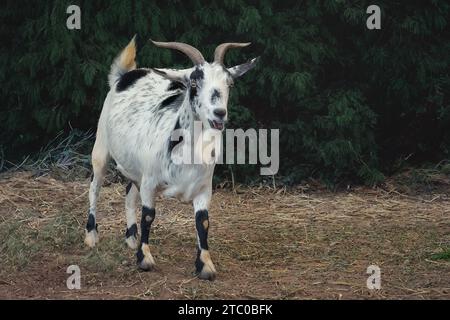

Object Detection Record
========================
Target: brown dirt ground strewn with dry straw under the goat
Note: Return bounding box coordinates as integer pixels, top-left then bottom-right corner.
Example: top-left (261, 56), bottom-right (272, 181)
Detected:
top-left (0, 173), bottom-right (450, 299)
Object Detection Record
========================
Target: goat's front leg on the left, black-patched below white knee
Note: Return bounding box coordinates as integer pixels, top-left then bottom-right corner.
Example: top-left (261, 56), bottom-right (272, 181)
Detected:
top-left (136, 181), bottom-right (155, 271)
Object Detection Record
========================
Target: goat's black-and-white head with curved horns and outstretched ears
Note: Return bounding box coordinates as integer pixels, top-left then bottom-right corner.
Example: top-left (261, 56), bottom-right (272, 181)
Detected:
top-left (152, 41), bottom-right (257, 130)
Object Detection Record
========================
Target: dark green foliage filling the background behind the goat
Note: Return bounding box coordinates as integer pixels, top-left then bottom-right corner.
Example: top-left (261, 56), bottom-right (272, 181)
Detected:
top-left (0, 0), bottom-right (450, 184)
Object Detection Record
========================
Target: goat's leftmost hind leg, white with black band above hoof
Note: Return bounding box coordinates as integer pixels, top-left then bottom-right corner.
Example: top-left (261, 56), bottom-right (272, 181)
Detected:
top-left (84, 139), bottom-right (109, 248)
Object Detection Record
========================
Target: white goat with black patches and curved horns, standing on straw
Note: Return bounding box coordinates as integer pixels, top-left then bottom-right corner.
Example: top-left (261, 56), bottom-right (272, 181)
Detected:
top-left (85, 38), bottom-right (257, 280)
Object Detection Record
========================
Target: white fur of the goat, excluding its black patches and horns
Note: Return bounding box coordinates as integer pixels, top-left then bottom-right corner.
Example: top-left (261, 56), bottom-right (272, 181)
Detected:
top-left (86, 39), bottom-right (256, 276)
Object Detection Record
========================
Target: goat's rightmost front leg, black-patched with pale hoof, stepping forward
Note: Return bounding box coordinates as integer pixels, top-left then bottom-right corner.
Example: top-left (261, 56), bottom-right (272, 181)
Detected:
top-left (193, 189), bottom-right (216, 281)
